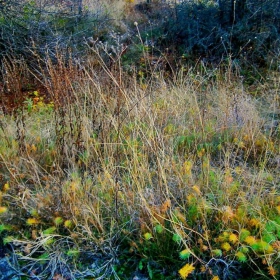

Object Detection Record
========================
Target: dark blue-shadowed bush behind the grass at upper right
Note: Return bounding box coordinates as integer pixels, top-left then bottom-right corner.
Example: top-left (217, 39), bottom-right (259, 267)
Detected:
top-left (134, 0), bottom-right (280, 67)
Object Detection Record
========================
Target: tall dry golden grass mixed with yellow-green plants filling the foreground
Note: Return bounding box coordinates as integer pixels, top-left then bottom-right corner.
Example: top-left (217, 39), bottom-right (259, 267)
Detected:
top-left (0, 53), bottom-right (280, 279)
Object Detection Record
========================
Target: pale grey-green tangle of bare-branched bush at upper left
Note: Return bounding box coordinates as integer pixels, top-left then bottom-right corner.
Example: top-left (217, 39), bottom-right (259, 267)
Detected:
top-left (0, 0), bottom-right (111, 70)
